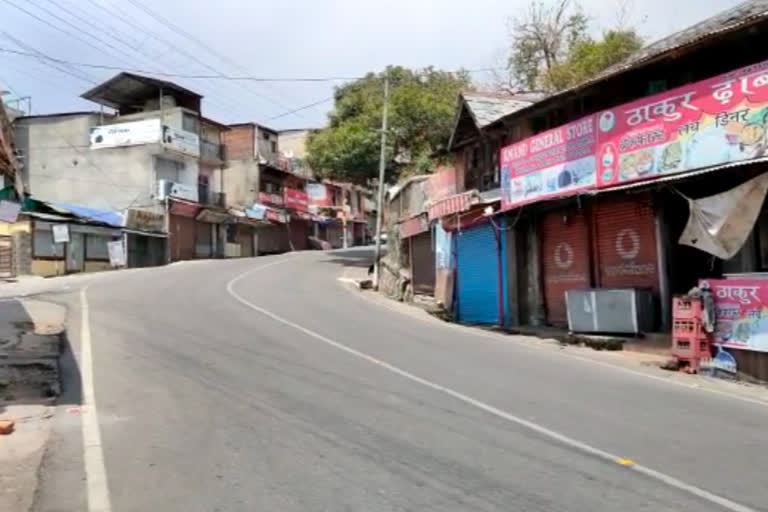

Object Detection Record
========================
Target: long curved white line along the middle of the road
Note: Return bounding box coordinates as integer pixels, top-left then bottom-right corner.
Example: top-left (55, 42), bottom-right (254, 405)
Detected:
top-left (227, 260), bottom-right (758, 512)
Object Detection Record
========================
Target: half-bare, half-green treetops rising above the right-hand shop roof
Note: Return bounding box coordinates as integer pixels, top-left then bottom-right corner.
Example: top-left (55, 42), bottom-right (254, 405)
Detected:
top-left (505, 0), bottom-right (643, 92)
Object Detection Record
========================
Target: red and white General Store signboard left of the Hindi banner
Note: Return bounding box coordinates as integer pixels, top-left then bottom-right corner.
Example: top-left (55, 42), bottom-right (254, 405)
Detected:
top-left (501, 116), bottom-right (596, 210)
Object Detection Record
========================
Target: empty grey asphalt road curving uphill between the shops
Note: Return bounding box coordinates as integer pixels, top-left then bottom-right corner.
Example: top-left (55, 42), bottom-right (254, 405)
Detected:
top-left (27, 250), bottom-right (768, 512)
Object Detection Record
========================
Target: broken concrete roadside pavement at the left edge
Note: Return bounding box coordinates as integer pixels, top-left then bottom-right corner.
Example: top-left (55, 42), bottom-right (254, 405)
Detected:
top-left (0, 299), bottom-right (66, 512)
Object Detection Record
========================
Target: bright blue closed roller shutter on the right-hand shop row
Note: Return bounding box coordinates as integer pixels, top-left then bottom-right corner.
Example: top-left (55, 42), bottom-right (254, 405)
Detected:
top-left (456, 223), bottom-right (499, 324)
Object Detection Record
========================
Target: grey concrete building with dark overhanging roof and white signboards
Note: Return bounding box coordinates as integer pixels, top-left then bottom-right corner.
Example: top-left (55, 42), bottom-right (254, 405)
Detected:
top-left (14, 73), bottom-right (230, 264)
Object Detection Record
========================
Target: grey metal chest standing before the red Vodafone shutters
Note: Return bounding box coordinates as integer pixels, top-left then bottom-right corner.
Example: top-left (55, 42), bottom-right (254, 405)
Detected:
top-left (565, 288), bottom-right (656, 334)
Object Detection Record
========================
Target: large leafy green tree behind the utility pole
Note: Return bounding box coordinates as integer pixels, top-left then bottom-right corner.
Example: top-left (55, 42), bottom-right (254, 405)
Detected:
top-left (307, 66), bottom-right (470, 183)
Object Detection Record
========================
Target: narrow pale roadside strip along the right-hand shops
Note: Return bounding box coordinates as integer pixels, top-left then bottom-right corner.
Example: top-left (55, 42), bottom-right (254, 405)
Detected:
top-left (339, 267), bottom-right (768, 406)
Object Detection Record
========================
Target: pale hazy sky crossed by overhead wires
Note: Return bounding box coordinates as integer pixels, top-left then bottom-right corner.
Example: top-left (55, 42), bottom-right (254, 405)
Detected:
top-left (0, 0), bottom-right (741, 129)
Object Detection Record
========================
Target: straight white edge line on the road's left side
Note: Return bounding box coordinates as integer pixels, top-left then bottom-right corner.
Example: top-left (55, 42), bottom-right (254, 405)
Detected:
top-left (80, 287), bottom-right (112, 512)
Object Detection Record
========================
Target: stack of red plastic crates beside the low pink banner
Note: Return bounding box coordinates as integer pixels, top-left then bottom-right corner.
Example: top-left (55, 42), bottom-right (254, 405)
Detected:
top-left (672, 295), bottom-right (712, 372)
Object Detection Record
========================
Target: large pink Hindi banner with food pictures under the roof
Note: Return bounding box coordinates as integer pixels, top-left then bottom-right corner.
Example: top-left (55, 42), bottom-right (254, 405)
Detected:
top-left (597, 61), bottom-right (768, 187)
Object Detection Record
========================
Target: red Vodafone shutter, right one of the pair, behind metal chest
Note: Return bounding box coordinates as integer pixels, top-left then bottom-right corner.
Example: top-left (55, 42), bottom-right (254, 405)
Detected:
top-left (595, 194), bottom-right (659, 291)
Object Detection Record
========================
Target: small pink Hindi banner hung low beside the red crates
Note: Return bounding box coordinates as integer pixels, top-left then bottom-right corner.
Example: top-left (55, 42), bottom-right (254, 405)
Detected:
top-left (699, 279), bottom-right (768, 352)
